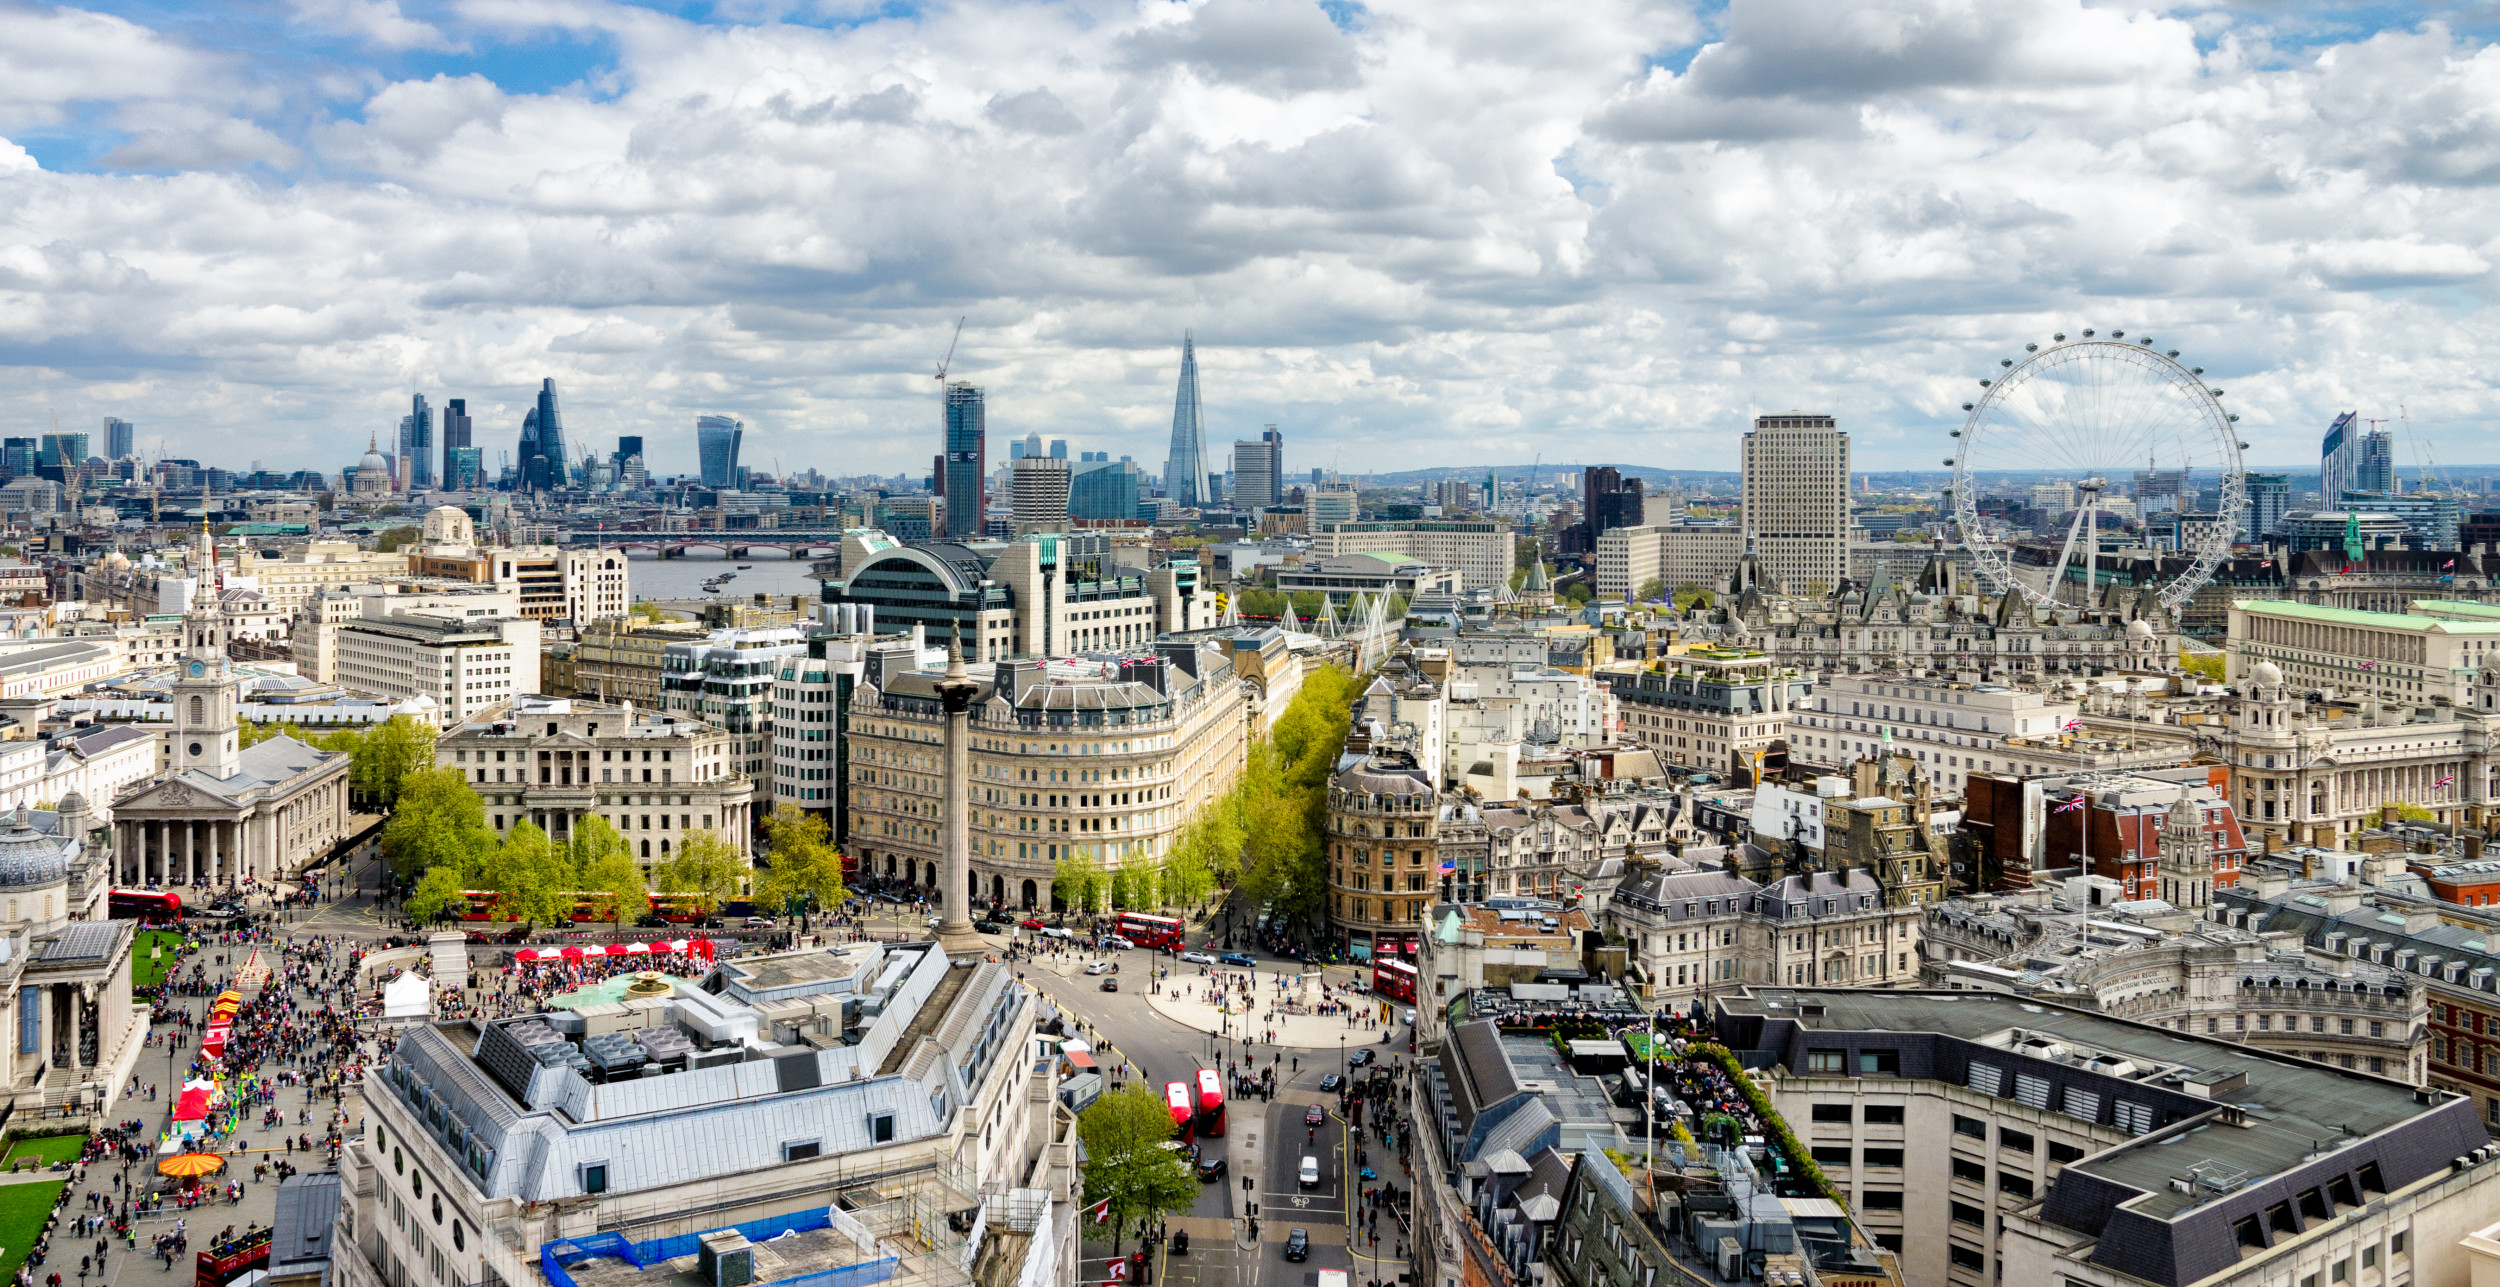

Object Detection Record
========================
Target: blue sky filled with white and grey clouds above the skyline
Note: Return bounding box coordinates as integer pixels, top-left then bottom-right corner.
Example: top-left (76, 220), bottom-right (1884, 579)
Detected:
top-left (0, 0), bottom-right (2500, 484)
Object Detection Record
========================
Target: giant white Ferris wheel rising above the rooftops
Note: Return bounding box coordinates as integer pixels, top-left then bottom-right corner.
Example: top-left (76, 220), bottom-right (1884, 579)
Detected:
top-left (1945, 330), bottom-right (2248, 615)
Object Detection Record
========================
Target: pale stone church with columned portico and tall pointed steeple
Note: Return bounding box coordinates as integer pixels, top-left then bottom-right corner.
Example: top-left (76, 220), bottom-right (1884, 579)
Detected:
top-left (113, 602), bottom-right (353, 890)
